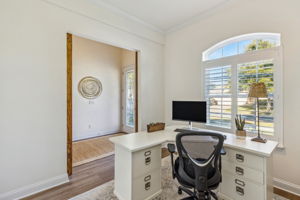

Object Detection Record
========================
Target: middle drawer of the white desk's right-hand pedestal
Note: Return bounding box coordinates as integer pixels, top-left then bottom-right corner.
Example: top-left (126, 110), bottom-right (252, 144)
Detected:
top-left (222, 160), bottom-right (264, 184)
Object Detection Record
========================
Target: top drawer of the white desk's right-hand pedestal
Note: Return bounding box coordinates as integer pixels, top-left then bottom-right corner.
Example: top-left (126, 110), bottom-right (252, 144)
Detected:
top-left (222, 148), bottom-right (264, 171)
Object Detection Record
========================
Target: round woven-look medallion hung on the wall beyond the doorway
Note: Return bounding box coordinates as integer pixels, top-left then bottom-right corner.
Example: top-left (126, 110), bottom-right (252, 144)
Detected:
top-left (78, 76), bottom-right (102, 99)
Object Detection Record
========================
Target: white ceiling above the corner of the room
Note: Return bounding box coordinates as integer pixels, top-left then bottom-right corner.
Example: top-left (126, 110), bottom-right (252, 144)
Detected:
top-left (93, 0), bottom-right (228, 32)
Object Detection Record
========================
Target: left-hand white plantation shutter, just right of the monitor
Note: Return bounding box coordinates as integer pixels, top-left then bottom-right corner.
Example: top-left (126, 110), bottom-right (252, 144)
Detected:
top-left (205, 66), bottom-right (232, 128)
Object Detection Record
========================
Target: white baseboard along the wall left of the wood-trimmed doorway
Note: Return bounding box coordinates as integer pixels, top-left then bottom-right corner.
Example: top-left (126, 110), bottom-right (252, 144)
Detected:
top-left (0, 174), bottom-right (69, 200)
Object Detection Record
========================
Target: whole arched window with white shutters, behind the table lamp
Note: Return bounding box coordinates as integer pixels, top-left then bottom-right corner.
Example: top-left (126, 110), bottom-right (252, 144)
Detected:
top-left (203, 33), bottom-right (282, 144)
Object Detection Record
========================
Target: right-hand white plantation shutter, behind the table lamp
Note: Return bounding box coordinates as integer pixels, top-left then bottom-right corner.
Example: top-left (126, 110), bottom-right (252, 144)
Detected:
top-left (237, 60), bottom-right (275, 135)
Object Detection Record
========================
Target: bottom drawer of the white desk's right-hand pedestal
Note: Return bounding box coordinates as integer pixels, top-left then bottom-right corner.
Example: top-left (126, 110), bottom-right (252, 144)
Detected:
top-left (220, 172), bottom-right (264, 200)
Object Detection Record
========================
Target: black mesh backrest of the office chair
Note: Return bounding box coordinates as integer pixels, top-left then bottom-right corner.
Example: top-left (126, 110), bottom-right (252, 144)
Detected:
top-left (176, 131), bottom-right (224, 191)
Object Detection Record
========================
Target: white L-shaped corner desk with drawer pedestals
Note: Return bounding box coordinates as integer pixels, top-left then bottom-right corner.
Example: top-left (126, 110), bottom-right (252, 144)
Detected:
top-left (110, 126), bottom-right (278, 200)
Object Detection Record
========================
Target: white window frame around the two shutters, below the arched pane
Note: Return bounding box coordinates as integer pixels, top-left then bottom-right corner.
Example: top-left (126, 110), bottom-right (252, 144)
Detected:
top-left (201, 46), bottom-right (284, 147)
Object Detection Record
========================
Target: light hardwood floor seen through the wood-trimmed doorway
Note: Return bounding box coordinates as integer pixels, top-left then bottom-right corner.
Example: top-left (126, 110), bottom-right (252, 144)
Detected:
top-left (72, 133), bottom-right (125, 167)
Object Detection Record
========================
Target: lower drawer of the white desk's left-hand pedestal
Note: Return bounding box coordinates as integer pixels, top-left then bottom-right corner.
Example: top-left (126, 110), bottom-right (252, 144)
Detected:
top-left (132, 169), bottom-right (161, 200)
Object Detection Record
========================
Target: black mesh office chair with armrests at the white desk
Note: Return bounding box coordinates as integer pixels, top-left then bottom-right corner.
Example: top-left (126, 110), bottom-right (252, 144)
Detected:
top-left (168, 131), bottom-right (225, 200)
